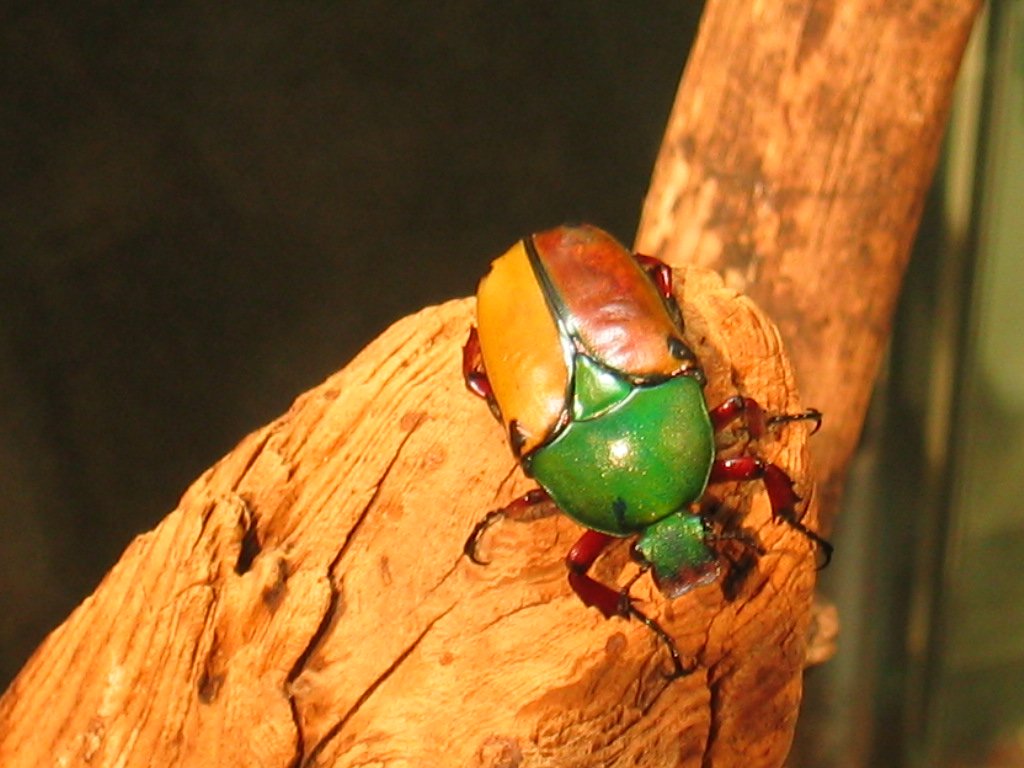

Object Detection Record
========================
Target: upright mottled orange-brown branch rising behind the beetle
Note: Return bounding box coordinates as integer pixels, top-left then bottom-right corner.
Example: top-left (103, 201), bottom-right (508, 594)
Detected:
top-left (637, 0), bottom-right (981, 520)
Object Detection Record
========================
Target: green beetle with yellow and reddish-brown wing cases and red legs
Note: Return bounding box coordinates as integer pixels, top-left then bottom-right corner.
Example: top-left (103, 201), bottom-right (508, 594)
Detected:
top-left (462, 224), bottom-right (833, 677)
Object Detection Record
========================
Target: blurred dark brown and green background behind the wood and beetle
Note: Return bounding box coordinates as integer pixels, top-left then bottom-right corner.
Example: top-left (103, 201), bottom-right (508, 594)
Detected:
top-left (0, 0), bottom-right (1024, 768)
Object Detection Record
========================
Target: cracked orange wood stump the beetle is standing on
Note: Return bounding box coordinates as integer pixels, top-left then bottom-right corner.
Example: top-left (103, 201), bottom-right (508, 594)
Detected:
top-left (0, 268), bottom-right (814, 767)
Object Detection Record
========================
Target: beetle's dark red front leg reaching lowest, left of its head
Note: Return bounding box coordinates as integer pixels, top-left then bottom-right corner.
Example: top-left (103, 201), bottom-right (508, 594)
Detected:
top-left (565, 530), bottom-right (692, 680)
